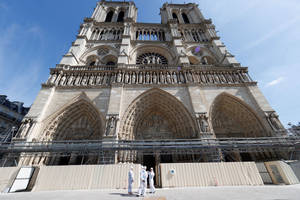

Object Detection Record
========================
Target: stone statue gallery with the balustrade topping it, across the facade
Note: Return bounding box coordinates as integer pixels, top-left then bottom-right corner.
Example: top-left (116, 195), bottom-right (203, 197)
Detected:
top-left (44, 65), bottom-right (256, 86)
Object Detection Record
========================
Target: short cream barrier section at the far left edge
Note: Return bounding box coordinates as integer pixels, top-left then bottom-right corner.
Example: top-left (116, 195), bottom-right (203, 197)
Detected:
top-left (0, 167), bottom-right (19, 192)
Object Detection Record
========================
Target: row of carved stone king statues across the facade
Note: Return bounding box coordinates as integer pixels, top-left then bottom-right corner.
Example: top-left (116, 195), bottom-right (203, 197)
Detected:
top-left (46, 70), bottom-right (251, 86)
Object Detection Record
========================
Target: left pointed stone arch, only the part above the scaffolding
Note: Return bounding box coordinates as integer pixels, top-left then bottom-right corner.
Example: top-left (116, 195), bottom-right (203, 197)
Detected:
top-left (40, 92), bottom-right (105, 141)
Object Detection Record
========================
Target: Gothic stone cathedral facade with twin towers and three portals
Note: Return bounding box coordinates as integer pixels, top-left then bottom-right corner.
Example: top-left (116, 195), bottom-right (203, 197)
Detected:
top-left (15, 1), bottom-right (285, 165)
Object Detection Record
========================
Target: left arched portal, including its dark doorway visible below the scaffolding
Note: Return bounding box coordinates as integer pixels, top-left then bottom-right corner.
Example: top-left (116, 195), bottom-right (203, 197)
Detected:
top-left (39, 93), bottom-right (104, 165)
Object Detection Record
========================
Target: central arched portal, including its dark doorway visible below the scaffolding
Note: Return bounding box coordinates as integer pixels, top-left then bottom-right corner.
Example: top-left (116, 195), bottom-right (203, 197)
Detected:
top-left (118, 88), bottom-right (197, 167)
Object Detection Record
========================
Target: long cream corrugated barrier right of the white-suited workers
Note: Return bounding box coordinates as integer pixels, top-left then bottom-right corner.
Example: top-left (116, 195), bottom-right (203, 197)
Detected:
top-left (160, 162), bottom-right (263, 188)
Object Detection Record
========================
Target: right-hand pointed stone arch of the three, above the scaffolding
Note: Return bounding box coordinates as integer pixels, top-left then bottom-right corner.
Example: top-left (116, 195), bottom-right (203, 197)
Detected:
top-left (210, 92), bottom-right (269, 138)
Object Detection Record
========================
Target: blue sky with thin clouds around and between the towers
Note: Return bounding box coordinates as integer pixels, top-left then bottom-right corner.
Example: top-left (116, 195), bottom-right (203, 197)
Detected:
top-left (0, 0), bottom-right (300, 125)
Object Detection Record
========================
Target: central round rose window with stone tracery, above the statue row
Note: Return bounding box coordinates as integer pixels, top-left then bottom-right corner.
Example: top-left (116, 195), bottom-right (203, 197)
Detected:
top-left (136, 52), bottom-right (168, 65)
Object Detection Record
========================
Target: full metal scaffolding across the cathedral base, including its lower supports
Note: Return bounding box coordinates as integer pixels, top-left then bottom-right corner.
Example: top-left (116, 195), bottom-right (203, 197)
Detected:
top-left (0, 137), bottom-right (300, 163)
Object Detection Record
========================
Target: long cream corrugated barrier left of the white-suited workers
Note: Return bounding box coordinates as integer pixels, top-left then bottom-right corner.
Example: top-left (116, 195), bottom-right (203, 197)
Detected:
top-left (33, 164), bottom-right (140, 191)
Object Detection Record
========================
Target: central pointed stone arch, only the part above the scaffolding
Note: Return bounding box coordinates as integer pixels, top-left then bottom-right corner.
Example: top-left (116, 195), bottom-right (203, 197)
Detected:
top-left (118, 88), bottom-right (196, 140)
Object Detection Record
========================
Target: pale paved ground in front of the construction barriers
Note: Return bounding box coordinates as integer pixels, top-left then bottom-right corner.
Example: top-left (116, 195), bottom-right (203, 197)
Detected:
top-left (0, 184), bottom-right (300, 200)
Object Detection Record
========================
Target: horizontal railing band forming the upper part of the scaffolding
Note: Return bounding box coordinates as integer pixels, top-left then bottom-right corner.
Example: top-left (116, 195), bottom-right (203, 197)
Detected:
top-left (0, 137), bottom-right (300, 154)
